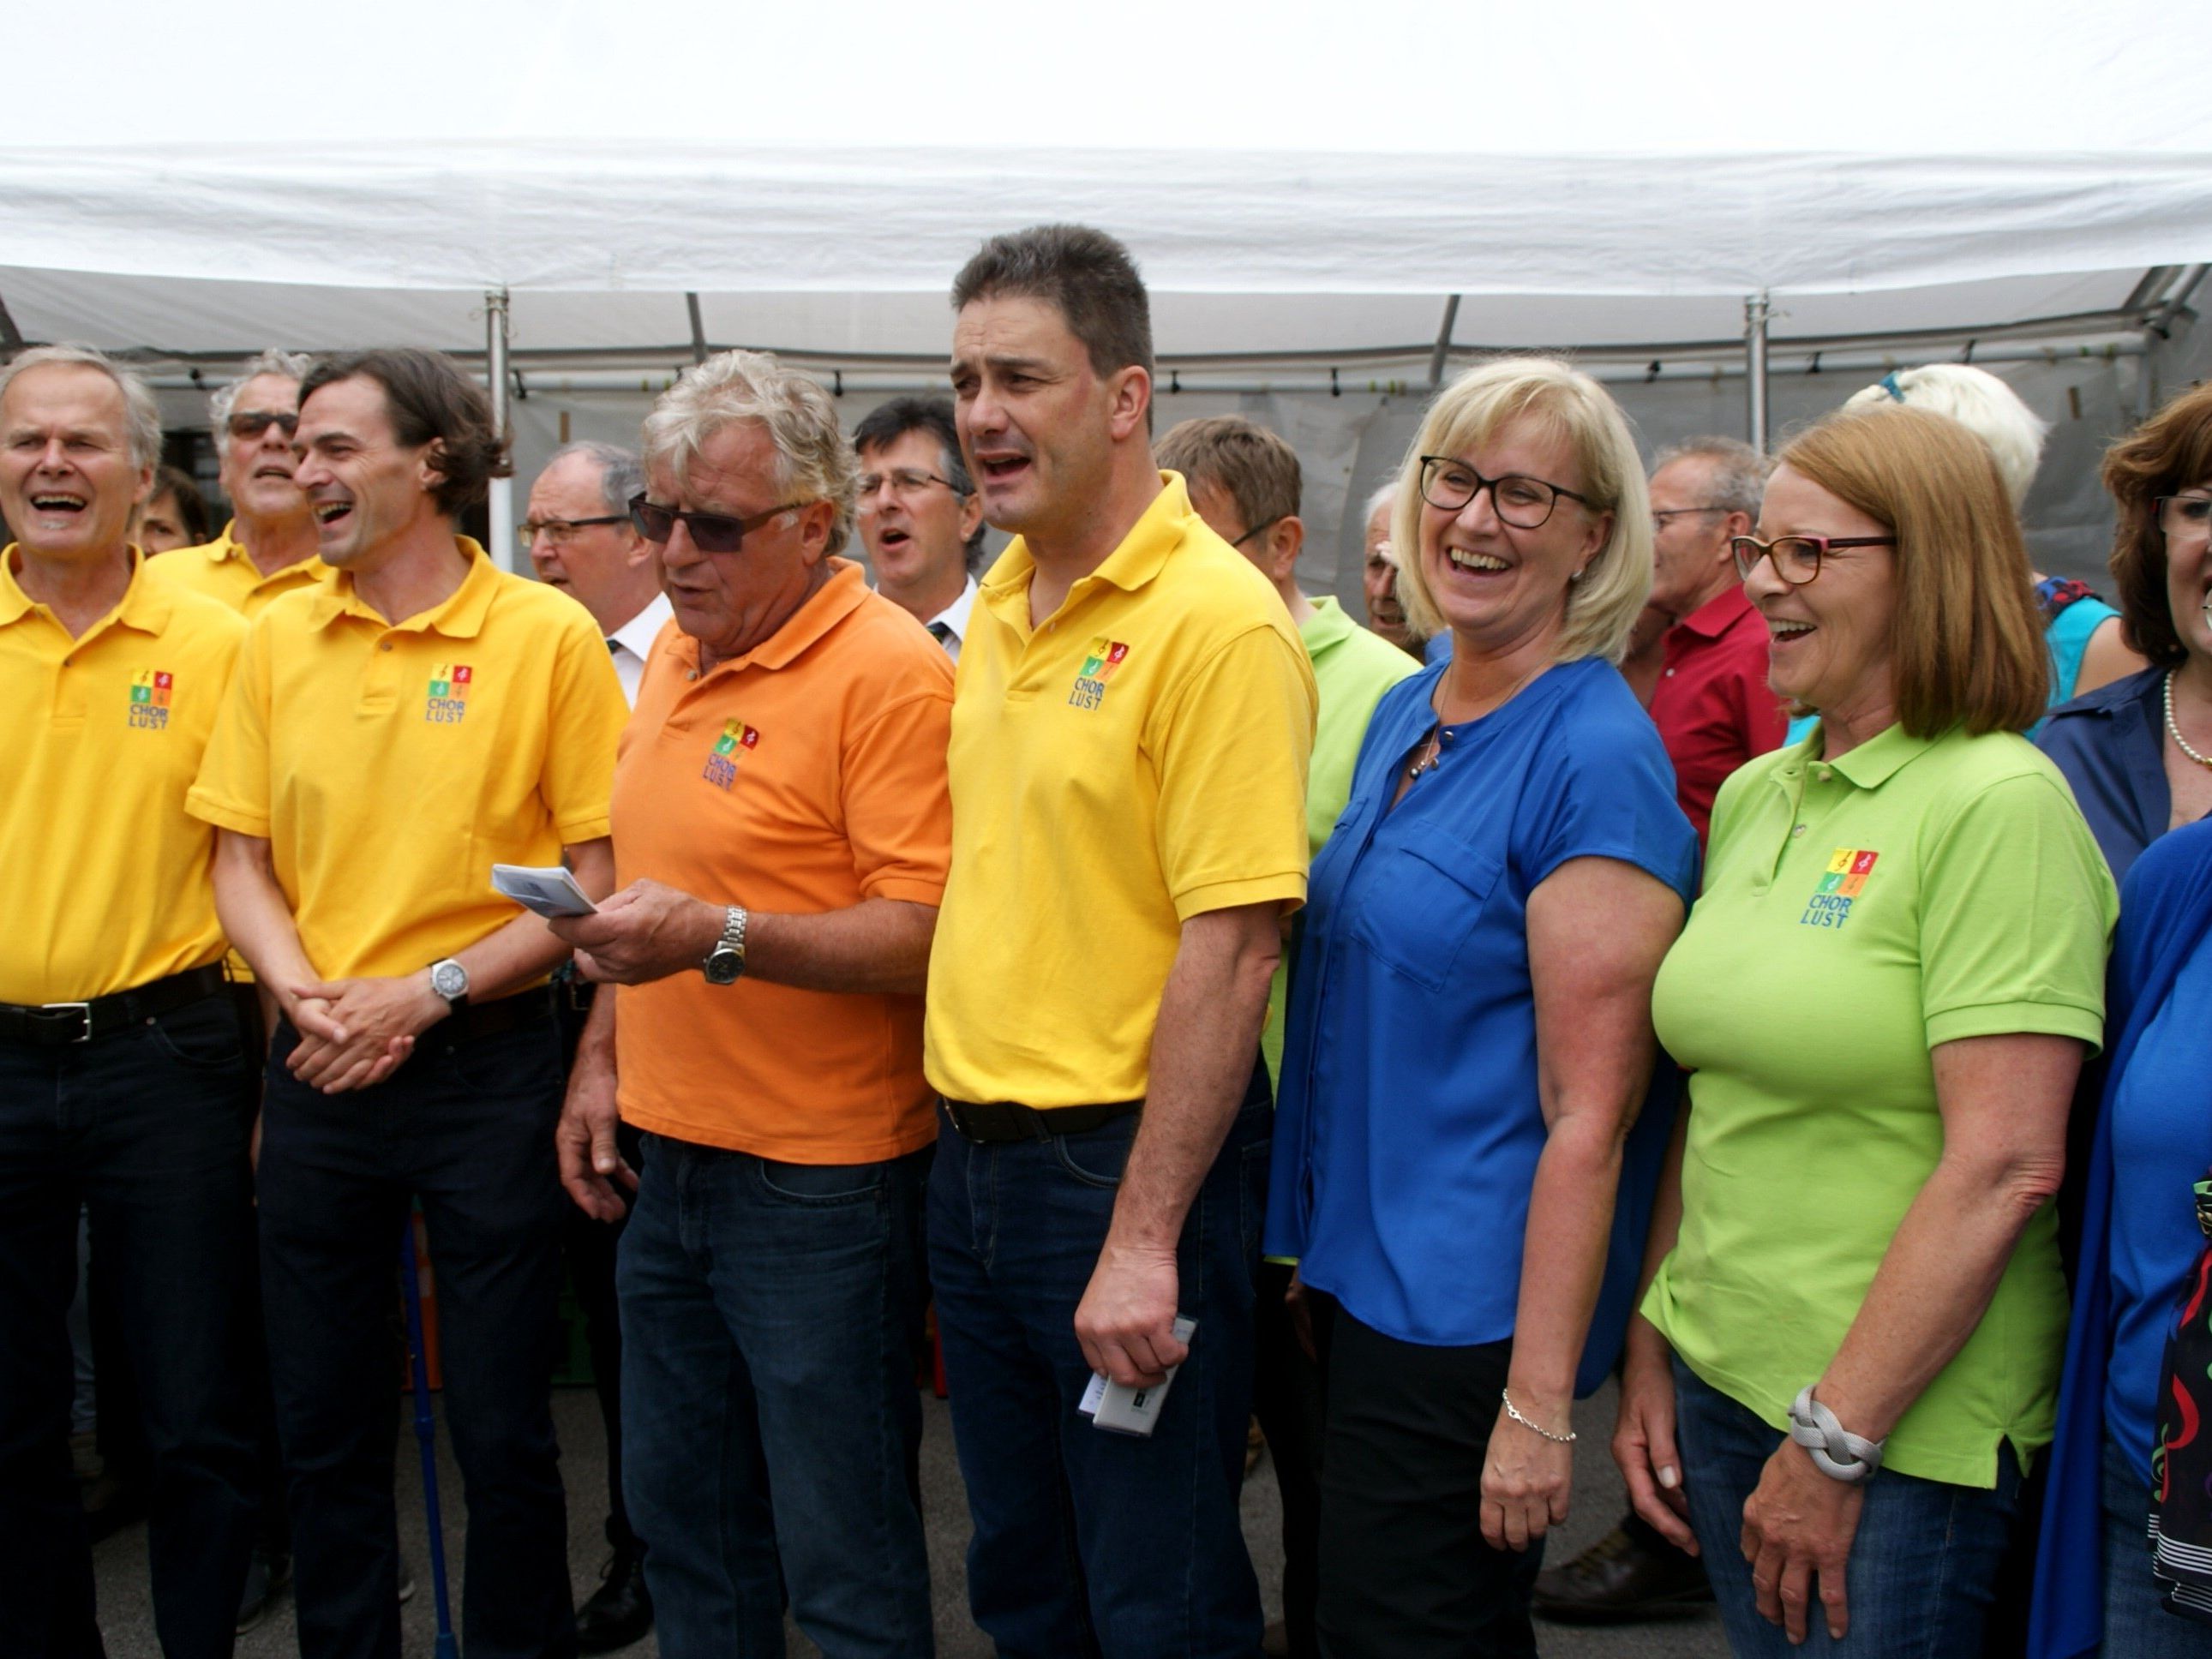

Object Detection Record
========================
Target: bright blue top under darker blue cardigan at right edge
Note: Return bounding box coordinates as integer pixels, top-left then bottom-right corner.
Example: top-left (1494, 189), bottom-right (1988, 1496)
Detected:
top-left (2104, 940), bottom-right (2212, 1484)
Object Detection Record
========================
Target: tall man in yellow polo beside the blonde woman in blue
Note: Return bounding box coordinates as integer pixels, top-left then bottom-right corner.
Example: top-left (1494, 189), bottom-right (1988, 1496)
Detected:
top-left (925, 225), bottom-right (1316, 1659)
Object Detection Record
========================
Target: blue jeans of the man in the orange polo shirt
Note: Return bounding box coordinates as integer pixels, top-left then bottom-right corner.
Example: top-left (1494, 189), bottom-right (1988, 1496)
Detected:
top-left (615, 1135), bottom-right (933, 1659)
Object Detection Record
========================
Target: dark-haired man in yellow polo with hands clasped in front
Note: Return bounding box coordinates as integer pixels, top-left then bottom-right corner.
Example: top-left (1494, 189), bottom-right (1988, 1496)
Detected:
top-left (188, 350), bottom-right (626, 1659)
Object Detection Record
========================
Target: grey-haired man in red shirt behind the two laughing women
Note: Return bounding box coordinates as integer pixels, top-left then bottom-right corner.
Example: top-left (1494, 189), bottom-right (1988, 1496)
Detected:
top-left (1650, 438), bottom-right (1789, 845)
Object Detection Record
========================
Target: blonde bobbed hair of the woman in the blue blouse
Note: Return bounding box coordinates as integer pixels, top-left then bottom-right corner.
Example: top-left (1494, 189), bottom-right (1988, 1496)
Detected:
top-left (1389, 356), bottom-right (1652, 663)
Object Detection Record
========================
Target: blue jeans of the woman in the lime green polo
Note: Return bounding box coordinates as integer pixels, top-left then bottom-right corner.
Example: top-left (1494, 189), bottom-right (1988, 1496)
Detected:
top-left (1675, 1361), bottom-right (2019, 1659)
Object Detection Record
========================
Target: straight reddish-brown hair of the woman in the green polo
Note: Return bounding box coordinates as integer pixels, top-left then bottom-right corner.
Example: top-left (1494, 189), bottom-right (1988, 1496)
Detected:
top-left (1777, 404), bottom-right (2051, 737)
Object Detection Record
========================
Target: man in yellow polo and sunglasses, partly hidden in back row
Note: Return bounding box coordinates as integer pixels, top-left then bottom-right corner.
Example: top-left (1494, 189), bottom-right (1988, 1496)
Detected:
top-left (146, 347), bottom-right (330, 617)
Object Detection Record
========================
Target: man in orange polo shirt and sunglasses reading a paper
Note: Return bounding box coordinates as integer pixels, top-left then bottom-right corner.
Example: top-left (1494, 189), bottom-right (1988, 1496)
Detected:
top-left (555, 351), bottom-right (953, 1655)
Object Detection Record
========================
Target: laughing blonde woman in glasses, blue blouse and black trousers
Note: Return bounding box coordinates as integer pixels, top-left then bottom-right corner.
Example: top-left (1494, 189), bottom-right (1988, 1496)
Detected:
top-left (1268, 358), bottom-right (1697, 1659)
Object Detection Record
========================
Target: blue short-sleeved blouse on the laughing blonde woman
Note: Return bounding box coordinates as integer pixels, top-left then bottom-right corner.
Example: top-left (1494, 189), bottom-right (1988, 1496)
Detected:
top-left (1268, 657), bottom-right (1697, 1347)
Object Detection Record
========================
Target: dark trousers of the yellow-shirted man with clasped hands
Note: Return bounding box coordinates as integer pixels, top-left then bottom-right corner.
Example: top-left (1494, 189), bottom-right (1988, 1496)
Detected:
top-left (261, 1013), bottom-right (575, 1659)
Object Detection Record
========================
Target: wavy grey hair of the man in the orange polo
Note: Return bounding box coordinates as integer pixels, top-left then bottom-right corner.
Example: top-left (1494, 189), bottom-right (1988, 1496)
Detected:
top-left (644, 351), bottom-right (860, 553)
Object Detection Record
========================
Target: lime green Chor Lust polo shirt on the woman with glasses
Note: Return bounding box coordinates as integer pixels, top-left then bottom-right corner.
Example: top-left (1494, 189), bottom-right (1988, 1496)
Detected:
top-left (1644, 726), bottom-right (2119, 1488)
